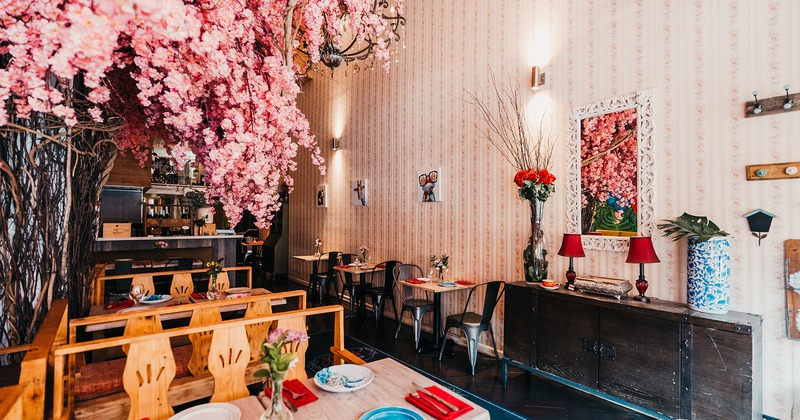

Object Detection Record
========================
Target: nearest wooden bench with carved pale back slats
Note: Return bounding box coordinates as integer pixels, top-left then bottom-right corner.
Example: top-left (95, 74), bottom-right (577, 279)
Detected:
top-left (53, 291), bottom-right (363, 420)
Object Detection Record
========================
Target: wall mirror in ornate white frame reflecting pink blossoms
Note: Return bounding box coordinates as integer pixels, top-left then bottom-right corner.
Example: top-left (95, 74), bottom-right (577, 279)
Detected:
top-left (567, 89), bottom-right (655, 251)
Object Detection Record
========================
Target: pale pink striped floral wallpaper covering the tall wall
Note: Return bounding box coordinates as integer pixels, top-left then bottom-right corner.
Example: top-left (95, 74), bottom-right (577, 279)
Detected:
top-left (289, 0), bottom-right (800, 418)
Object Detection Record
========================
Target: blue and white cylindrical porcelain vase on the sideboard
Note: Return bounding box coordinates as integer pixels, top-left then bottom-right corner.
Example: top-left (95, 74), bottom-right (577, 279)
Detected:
top-left (687, 238), bottom-right (731, 314)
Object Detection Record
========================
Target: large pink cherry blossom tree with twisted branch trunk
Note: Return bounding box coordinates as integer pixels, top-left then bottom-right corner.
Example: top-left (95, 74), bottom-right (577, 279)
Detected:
top-left (0, 0), bottom-right (402, 345)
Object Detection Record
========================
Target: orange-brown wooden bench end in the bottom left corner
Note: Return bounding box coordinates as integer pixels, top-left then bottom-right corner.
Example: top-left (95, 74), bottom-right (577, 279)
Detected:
top-left (0, 299), bottom-right (69, 419)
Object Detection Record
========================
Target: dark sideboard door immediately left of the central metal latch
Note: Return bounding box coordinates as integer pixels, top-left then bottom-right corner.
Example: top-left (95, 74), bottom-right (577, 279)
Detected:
top-left (536, 295), bottom-right (597, 389)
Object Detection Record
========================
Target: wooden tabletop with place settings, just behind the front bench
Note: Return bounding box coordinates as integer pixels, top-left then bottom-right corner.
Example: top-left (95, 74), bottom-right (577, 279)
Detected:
top-left (80, 288), bottom-right (286, 332)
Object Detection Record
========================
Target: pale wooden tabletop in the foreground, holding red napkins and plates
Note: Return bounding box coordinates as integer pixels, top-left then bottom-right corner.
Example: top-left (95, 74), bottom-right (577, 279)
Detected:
top-left (293, 358), bottom-right (490, 420)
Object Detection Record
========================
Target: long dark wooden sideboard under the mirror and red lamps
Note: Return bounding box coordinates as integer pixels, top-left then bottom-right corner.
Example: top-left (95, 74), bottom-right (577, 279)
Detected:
top-left (502, 282), bottom-right (762, 419)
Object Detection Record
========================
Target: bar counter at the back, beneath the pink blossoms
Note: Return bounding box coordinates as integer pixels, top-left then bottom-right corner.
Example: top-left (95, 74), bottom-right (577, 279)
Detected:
top-left (93, 235), bottom-right (242, 266)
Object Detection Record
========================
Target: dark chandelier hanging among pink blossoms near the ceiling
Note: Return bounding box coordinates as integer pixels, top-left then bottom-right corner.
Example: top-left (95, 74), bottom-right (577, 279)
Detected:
top-left (300, 0), bottom-right (406, 71)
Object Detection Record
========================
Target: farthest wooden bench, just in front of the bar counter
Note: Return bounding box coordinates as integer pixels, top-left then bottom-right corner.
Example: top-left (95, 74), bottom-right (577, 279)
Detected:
top-left (91, 267), bottom-right (253, 305)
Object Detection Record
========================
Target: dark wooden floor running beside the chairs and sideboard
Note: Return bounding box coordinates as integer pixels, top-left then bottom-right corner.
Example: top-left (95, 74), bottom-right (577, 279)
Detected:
top-left (264, 281), bottom-right (649, 419)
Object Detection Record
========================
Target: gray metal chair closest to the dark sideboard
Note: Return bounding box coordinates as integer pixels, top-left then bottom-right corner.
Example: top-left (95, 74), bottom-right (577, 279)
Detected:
top-left (439, 280), bottom-right (508, 375)
